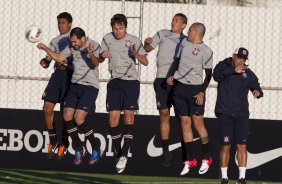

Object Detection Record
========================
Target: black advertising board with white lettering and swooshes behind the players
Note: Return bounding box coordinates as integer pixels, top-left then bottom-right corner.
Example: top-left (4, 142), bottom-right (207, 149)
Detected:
top-left (0, 109), bottom-right (282, 181)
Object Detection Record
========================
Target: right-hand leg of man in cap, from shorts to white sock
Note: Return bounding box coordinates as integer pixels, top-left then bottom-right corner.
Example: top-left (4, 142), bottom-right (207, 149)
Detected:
top-left (235, 116), bottom-right (249, 184)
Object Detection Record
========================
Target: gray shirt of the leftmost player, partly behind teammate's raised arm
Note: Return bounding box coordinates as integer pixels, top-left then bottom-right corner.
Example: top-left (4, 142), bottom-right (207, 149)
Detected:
top-left (49, 31), bottom-right (71, 67)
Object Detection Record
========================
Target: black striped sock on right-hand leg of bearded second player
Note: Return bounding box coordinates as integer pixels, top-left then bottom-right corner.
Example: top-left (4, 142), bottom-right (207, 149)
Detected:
top-left (78, 121), bottom-right (100, 151)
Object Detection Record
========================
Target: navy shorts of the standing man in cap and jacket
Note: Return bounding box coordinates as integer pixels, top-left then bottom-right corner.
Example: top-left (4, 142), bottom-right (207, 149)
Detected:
top-left (217, 114), bottom-right (249, 145)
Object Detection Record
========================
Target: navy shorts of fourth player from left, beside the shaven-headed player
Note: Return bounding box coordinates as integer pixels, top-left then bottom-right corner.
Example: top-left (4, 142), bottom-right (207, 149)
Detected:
top-left (154, 78), bottom-right (172, 110)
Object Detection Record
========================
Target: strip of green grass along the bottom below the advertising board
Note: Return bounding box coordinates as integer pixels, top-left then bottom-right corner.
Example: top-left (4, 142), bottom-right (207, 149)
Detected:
top-left (0, 169), bottom-right (282, 184)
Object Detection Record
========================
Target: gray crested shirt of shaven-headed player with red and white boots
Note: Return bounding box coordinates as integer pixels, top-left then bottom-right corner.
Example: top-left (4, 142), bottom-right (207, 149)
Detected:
top-left (173, 39), bottom-right (213, 85)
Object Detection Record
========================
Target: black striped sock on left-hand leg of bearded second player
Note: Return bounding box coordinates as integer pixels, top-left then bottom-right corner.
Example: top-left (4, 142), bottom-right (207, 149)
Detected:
top-left (65, 120), bottom-right (82, 151)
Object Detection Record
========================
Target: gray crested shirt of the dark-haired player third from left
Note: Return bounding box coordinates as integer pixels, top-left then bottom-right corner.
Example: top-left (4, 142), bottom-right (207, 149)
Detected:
top-left (100, 33), bottom-right (146, 80)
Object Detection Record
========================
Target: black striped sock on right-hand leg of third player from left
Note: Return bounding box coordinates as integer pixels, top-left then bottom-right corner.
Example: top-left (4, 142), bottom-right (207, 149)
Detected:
top-left (122, 124), bottom-right (134, 157)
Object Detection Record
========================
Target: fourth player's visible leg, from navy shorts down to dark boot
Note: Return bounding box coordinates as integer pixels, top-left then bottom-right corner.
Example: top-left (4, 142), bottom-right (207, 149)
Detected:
top-left (154, 78), bottom-right (172, 167)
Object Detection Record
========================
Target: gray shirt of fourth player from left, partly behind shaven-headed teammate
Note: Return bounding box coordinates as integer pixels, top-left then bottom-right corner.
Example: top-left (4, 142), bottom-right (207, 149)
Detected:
top-left (151, 29), bottom-right (186, 78)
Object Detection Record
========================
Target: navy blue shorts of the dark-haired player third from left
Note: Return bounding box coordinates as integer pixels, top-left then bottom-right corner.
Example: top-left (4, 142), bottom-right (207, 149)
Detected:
top-left (106, 79), bottom-right (140, 111)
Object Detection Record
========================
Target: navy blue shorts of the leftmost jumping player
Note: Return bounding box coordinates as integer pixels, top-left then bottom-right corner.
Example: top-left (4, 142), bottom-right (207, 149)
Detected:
top-left (41, 70), bottom-right (72, 104)
